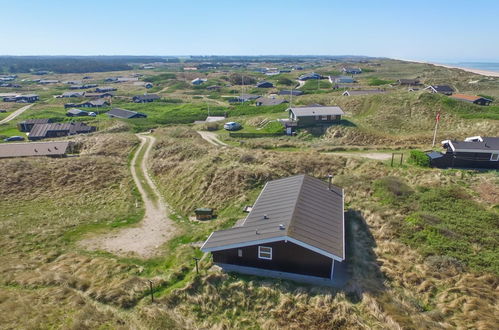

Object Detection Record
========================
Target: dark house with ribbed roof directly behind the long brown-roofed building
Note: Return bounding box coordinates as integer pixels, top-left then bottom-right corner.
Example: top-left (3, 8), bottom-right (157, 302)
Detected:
top-left (28, 122), bottom-right (96, 141)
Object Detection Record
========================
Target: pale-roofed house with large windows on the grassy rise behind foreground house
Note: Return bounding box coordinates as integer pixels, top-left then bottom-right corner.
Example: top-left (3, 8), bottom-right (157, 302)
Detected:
top-left (287, 105), bottom-right (345, 127)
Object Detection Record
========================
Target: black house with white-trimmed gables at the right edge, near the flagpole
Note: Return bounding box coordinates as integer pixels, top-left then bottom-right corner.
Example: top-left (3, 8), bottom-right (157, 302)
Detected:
top-left (427, 136), bottom-right (499, 169)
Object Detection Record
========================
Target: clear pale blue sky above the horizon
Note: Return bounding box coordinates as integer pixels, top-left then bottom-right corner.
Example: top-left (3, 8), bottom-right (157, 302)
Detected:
top-left (0, 0), bottom-right (499, 63)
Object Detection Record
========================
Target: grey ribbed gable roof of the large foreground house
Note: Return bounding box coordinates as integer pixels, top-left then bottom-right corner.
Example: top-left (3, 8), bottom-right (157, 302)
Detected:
top-left (201, 175), bottom-right (345, 259)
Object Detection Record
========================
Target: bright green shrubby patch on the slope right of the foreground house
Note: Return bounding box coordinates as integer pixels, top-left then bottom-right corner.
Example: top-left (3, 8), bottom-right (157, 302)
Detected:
top-left (374, 177), bottom-right (499, 274)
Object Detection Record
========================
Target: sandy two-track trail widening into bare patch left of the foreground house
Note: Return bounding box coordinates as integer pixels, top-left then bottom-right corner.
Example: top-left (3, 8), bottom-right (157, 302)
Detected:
top-left (81, 134), bottom-right (175, 258)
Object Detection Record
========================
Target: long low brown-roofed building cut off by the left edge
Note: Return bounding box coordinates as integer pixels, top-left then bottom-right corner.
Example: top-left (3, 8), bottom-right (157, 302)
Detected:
top-left (0, 141), bottom-right (73, 158)
